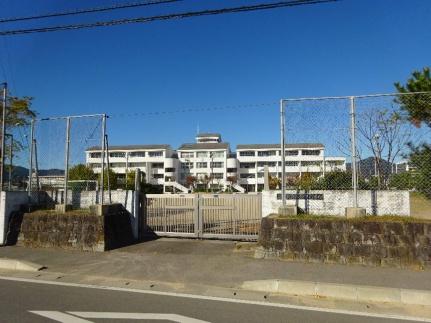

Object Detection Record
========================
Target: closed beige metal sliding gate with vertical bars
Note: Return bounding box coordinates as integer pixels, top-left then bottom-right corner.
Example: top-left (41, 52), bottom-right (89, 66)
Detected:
top-left (142, 194), bottom-right (262, 240)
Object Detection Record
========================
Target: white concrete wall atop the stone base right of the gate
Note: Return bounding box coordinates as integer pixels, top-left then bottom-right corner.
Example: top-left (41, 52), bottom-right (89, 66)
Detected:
top-left (262, 190), bottom-right (410, 217)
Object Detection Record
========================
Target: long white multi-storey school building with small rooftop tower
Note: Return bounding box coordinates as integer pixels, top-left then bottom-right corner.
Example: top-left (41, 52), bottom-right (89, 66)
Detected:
top-left (86, 133), bottom-right (346, 193)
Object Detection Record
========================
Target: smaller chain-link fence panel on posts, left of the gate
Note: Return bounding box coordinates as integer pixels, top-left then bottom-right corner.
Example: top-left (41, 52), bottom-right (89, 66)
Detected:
top-left (27, 115), bottom-right (109, 207)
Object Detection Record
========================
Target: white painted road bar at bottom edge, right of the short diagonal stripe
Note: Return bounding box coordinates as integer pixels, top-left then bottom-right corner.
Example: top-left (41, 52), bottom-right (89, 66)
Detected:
top-left (67, 312), bottom-right (210, 323)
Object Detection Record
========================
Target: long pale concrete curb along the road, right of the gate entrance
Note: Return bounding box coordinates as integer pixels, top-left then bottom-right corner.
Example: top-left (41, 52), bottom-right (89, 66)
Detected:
top-left (241, 279), bottom-right (431, 306)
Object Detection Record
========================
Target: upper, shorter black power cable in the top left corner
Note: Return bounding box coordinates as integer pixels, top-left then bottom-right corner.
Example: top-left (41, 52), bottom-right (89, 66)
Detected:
top-left (0, 0), bottom-right (184, 23)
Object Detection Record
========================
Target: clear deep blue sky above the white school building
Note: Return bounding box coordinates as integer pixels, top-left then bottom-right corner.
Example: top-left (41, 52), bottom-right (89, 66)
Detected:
top-left (0, 0), bottom-right (431, 167)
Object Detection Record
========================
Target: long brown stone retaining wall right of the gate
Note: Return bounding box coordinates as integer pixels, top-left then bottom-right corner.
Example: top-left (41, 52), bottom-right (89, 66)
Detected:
top-left (256, 216), bottom-right (431, 268)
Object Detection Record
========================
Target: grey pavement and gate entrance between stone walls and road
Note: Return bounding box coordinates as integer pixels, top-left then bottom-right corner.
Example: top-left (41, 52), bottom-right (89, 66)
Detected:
top-left (0, 238), bottom-right (431, 291)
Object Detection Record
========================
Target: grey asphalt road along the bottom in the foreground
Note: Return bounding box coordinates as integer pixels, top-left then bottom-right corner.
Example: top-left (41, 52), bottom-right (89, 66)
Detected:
top-left (0, 279), bottom-right (426, 323)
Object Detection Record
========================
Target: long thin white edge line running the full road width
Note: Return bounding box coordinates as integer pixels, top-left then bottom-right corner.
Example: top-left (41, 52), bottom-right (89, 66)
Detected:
top-left (0, 276), bottom-right (431, 323)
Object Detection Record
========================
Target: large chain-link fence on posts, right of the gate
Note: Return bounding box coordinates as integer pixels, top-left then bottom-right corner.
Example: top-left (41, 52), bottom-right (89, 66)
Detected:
top-left (282, 93), bottom-right (431, 215)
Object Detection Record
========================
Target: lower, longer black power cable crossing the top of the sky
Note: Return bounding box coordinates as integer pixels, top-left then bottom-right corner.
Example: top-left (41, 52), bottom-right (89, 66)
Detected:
top-left (0, 0), bottom-right (340, 36)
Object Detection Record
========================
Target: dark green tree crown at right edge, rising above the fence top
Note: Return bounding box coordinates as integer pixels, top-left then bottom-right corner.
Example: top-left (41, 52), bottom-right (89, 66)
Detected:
top-left (394, 67), bottom-right (431, 127)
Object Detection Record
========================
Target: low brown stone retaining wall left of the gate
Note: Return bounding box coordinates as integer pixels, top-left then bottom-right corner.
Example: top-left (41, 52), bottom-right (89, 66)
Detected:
top-left (16, 204), bottom-right (134, 251)
